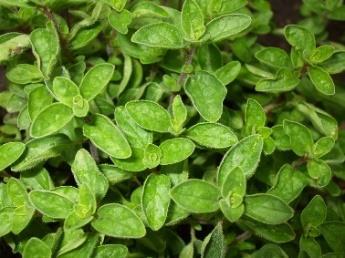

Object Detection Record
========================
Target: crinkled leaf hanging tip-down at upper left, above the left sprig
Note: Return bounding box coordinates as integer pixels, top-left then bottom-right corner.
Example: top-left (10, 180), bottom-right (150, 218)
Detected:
top-left (30, 23), bottom-right (60, 78)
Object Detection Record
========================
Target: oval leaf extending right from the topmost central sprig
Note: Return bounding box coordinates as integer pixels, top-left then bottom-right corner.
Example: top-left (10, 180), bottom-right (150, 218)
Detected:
top-left (201, 14), bottom-right (252, 42)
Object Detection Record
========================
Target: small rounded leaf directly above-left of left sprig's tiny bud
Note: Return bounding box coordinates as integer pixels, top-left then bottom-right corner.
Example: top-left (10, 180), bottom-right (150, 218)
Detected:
top-left (52, 76), bottom-right (79, 108)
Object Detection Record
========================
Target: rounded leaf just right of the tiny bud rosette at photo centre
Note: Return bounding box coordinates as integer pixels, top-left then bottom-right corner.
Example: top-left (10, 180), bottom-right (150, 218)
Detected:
top-left (159, 138), bottom-right (195, 165)
